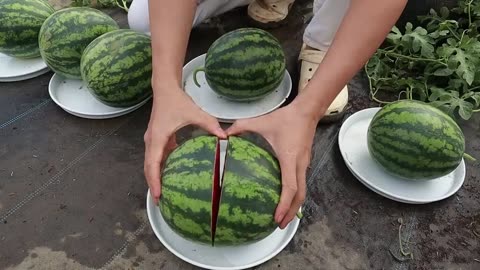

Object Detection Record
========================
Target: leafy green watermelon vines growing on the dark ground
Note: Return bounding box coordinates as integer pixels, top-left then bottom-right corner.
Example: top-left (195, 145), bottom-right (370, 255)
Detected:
top-left (365, 0), bottom-right (480, 120)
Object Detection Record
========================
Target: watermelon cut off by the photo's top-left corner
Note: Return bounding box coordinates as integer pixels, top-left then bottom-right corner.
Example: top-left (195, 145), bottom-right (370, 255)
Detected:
top-left (0, 0), bottom-right (55, 59)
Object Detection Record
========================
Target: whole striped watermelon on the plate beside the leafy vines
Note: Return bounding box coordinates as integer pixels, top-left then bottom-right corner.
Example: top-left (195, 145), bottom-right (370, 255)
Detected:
top-left (367, 100), bottom-right (465, 180)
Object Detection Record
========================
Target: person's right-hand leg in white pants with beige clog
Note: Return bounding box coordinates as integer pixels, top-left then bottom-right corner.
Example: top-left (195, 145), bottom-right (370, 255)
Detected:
top-left (298, 0), bottom-right (350, 122)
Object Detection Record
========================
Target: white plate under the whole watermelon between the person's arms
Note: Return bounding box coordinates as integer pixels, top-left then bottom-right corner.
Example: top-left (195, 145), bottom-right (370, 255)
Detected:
top-left (182, 54), bottom-right (292, 123)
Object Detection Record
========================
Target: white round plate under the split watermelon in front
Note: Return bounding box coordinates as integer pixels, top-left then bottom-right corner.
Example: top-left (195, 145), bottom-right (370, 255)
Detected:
top-left (147, 190), bottom-right (300, 270)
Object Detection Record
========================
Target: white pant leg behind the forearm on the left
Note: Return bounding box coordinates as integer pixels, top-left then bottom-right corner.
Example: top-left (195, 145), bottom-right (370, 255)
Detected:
top-left (128, 0), bottom-right (252, 33)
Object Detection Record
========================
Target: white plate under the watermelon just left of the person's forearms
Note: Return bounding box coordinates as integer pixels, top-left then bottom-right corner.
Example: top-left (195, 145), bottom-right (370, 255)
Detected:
top-left (48, 73), bottom-right (151, 119)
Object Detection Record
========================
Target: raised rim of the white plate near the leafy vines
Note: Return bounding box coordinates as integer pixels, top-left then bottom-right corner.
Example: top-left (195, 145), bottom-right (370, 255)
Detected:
top-left (338, 107), bottom-right (466, 204)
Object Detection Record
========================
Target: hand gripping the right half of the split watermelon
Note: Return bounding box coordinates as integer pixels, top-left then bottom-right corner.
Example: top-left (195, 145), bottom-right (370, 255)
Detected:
top-left (227, 103), bottom-right (318, 229)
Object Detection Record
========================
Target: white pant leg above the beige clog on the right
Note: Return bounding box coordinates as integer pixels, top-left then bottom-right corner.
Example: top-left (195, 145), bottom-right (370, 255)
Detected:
top-left (303, 0), bottom-right (350, 51)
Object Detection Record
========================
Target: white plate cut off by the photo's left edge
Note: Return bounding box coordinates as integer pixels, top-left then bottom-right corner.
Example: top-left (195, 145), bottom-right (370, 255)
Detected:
top-left (0, 53), bottom-right (50, 82)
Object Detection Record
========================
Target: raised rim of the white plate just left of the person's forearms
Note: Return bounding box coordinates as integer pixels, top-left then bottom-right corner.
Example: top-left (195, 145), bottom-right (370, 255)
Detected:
top-left (48, 73), bottom-right (153, 119)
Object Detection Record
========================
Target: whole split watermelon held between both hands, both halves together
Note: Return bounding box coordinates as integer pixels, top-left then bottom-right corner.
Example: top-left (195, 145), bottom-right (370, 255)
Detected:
top-left (159, 135), bottom-right (281, 246)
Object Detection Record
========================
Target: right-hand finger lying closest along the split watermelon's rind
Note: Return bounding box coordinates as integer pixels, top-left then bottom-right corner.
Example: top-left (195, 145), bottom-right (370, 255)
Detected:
top-left (275, 157), bottom-right (297, 224)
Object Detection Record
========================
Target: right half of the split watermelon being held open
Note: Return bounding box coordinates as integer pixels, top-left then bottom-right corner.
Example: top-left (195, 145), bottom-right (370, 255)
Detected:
top-left (215, 136), bottom-right (282, 246)
